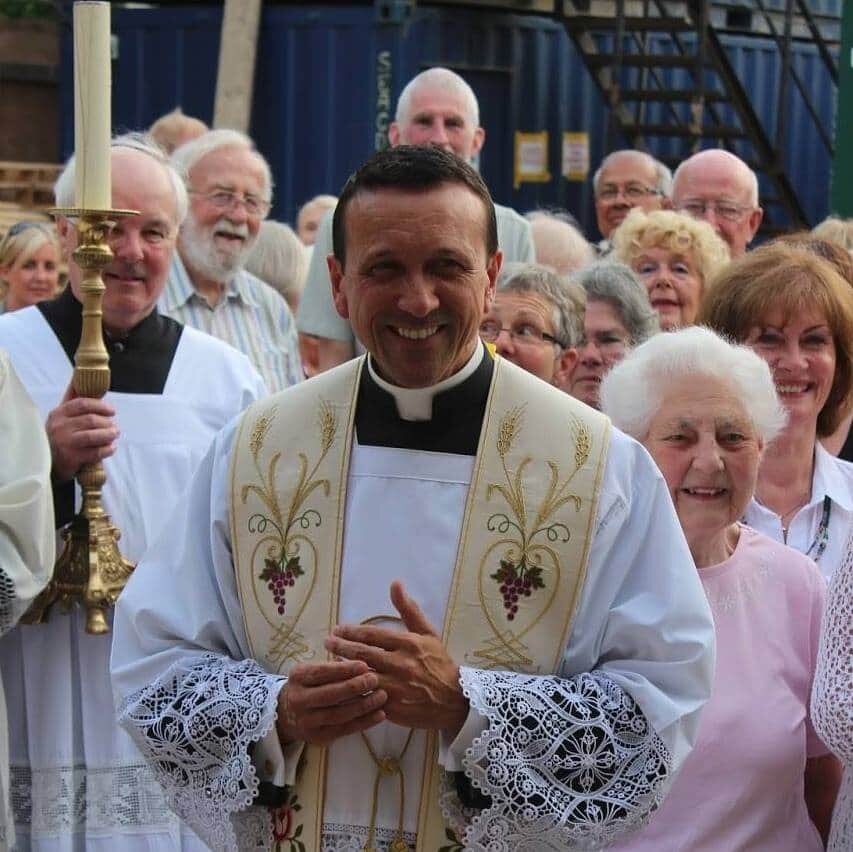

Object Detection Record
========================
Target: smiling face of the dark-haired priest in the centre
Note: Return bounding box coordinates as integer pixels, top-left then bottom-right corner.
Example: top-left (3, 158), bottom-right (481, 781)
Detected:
top-left (329, 183), bottom-right (501, 388)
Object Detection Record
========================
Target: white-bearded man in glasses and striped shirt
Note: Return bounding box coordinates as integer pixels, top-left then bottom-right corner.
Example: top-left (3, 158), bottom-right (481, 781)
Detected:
top-left (159, 130), bottom-right (303, 391)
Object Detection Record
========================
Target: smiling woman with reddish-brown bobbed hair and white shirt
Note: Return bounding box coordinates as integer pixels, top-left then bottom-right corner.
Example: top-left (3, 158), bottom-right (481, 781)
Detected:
top-left (699, 242), bottom-right (853, 578)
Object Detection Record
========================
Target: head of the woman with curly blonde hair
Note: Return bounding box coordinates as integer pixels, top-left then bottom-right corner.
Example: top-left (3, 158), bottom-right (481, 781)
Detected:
top-left (611, 208), bottom-right (729, 331)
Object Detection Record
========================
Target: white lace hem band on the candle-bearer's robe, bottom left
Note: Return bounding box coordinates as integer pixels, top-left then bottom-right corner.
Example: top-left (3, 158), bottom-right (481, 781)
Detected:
top-left (9, 763), bottom-right (179, 837)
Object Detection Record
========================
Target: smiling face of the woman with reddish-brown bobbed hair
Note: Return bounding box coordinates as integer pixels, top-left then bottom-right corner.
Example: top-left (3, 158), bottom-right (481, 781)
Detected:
top-left (745, 308), bottom-right (836, 429)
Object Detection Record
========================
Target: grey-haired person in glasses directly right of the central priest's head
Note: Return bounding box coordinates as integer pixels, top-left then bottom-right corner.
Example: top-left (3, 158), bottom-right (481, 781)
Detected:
top-left (480, 263), bottom-right (584, 388)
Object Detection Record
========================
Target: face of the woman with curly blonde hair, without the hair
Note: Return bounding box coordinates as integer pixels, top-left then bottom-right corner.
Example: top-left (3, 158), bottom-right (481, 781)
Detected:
top-left (631, 246), bottom-right (702, 331)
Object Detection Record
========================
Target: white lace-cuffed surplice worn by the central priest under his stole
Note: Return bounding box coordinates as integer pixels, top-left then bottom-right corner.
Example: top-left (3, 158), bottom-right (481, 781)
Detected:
top-left (112, 362), bottom-right (713, 852)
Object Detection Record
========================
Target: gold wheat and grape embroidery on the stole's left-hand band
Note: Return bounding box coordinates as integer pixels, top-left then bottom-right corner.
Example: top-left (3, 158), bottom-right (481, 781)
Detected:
top-left (240, 400), bottom-right (338, 666)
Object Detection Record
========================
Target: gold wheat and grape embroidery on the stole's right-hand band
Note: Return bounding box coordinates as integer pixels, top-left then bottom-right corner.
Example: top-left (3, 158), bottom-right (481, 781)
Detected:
top-left (474, 405), bottom-right (592, 670)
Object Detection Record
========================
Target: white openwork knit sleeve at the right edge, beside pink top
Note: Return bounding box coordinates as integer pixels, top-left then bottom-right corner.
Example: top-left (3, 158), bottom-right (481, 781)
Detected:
top-left (811, 534), bottom-right (853, 852)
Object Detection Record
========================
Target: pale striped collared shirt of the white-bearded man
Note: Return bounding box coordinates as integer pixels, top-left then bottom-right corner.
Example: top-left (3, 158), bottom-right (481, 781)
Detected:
top-left (158, 252), bottom-right (303, 393)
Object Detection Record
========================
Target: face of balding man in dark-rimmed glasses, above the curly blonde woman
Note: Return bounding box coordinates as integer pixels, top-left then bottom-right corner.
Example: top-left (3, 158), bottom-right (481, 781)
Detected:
top-left (595, 152), bottom-right (665, 239)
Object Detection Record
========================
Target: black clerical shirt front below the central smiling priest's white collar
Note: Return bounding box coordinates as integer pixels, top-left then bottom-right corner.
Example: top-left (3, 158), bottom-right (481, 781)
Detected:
top-left (355, 348), bottom-right (494, 456)
